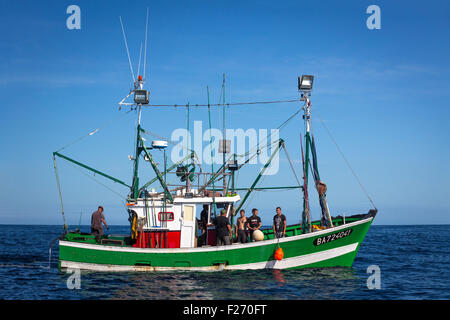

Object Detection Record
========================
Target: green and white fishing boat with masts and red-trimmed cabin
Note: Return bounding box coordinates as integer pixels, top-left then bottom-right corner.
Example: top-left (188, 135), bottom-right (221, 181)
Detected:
top-left (53, 15), bottom-right (377, 271)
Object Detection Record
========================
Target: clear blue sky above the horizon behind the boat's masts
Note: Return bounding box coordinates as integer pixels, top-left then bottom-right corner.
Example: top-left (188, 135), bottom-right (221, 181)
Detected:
top-left (0, 1), bottom-right (450, 224)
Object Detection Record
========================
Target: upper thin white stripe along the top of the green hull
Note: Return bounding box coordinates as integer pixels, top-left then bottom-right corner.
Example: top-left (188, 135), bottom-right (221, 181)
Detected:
top-left (59, 217), bottom-right (373, 253)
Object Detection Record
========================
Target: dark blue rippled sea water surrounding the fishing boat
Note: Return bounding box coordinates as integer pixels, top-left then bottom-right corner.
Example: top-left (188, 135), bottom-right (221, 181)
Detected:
top-left (0, 225), bottom-right (450, 300)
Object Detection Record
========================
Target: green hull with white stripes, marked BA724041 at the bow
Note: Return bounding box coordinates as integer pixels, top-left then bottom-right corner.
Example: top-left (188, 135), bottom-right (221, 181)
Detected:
top-left (59, 213), bottom-right (375, 271)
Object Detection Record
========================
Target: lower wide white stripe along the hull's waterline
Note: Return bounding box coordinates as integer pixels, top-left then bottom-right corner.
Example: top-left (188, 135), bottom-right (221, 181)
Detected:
top-left (61, 242), bottom-right (358, 272)
